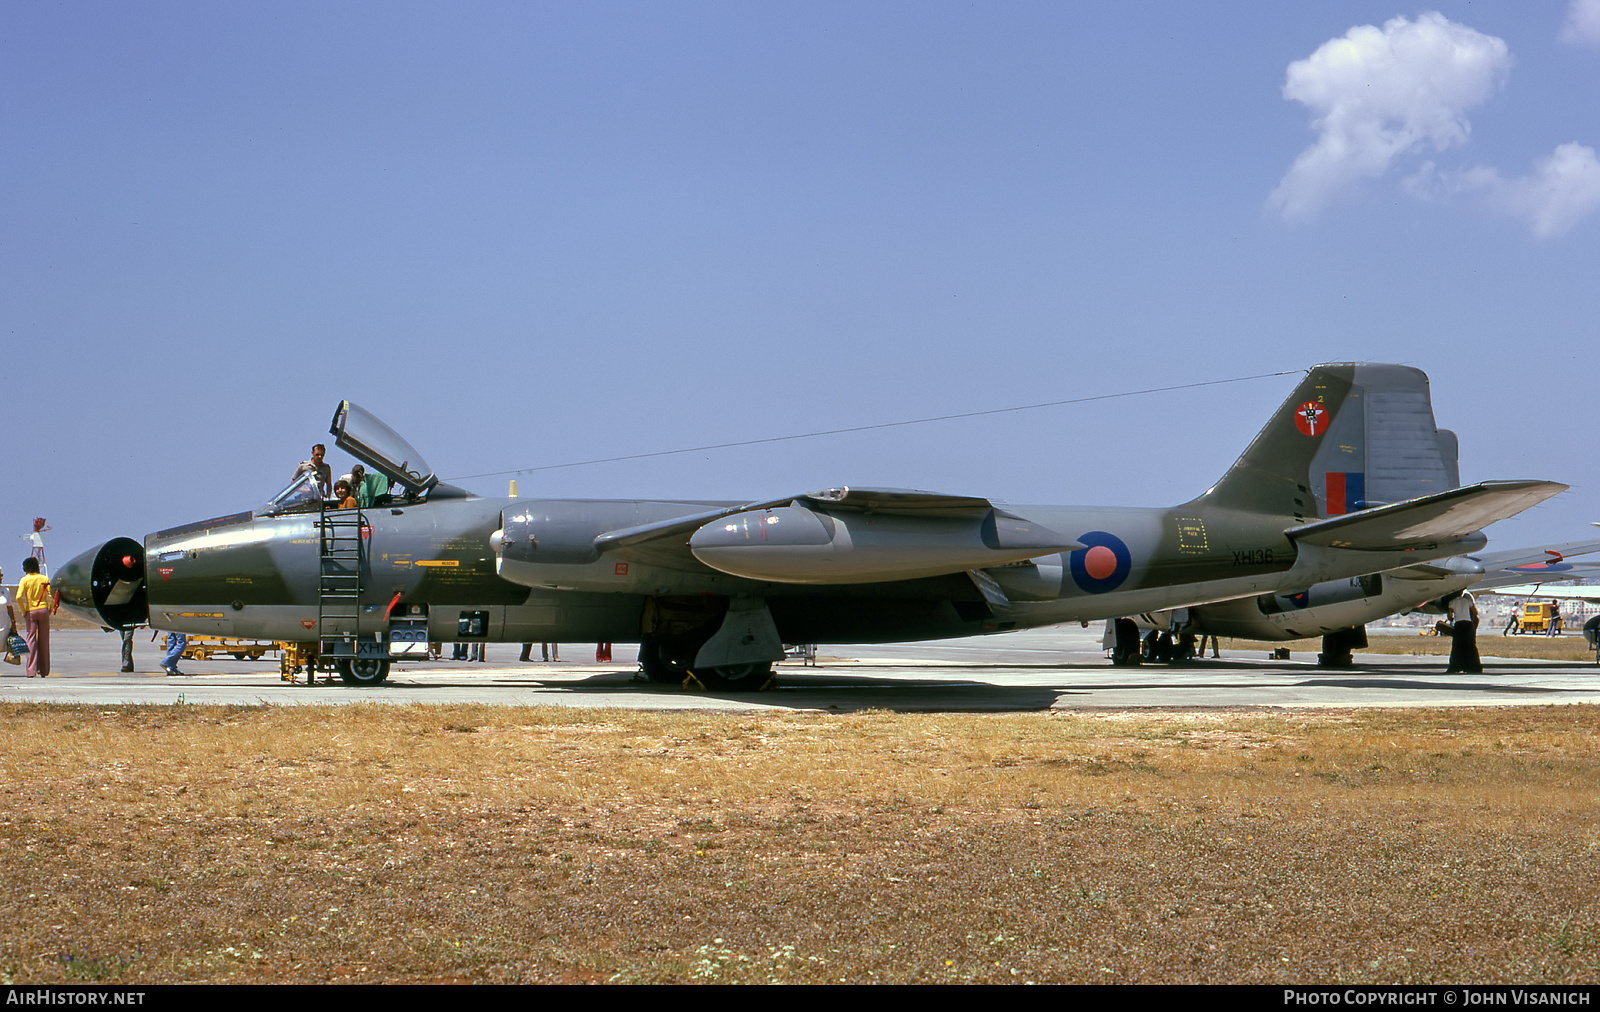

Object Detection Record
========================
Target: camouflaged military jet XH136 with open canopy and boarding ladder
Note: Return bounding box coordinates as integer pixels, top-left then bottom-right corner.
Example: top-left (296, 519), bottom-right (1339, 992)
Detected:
top-left (56, 363), bottom-right (1566, 689)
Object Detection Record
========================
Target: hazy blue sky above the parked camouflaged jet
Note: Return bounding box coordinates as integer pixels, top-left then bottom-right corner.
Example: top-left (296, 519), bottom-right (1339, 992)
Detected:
top-left (0, 0), bottom-right (1600, 572)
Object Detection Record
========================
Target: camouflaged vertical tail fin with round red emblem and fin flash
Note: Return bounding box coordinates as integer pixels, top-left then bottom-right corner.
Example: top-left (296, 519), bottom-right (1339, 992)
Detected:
top-left (1195, 362), bottom-right (1458, 519)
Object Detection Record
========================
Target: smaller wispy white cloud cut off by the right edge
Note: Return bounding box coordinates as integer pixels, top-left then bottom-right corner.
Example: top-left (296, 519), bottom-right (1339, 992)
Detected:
top-left (1433, 144), bottom-right (1600, 239)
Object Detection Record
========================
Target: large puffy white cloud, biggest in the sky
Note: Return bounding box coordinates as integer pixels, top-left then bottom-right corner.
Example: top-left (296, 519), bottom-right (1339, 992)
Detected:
top-left (1269, 13), bottom-right (1512, 221)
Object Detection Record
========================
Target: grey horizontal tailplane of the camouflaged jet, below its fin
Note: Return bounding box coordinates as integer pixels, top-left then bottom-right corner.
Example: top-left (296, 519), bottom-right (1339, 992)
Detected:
top-left (1283, 480), bottom-right (1568, 551)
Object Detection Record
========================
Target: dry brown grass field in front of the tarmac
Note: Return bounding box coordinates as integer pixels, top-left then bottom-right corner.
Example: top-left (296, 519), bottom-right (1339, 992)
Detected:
top-left (0, 705), bottom-right (1600, 983)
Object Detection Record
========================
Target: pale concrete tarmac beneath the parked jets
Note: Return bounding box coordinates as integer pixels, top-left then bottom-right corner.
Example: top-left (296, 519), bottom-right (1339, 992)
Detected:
top-left (0, 624), bottom-right (1600, 713)
